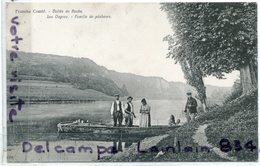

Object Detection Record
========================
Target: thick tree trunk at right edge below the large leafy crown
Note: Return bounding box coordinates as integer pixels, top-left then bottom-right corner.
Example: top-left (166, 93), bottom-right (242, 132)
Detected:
top-left (240, 64), bottom-right (257, 94)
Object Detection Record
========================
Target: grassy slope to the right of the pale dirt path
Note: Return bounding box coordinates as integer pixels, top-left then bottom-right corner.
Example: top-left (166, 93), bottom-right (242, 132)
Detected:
top-left (203, 91), bottom-right (258, 161)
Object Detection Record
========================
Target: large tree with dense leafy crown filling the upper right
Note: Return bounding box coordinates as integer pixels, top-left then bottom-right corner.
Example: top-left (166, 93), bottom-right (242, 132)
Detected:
top-left (161, 3), bottom-right (257, 93)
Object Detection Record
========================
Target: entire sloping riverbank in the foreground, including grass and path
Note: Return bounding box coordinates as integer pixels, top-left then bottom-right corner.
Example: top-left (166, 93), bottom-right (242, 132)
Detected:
top-left (102, 90), bottom-right (258, 162)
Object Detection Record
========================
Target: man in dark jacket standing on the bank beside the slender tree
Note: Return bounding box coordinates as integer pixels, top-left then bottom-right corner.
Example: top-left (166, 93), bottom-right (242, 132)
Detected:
top-left (184, 92), bottom-right (197, 122)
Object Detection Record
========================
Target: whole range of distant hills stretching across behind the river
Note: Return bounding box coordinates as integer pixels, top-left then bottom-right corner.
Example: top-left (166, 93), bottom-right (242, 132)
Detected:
top-left (7, 51), bottom-right (231, 99)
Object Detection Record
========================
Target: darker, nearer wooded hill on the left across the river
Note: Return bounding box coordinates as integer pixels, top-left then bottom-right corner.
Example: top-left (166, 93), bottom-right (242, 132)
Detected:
top-left (7, 52), bottom-right (128, 96)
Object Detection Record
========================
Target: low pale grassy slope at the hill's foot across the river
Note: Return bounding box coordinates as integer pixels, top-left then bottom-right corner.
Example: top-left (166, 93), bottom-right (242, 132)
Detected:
top-left (8, 80), bottom-right (113, 101)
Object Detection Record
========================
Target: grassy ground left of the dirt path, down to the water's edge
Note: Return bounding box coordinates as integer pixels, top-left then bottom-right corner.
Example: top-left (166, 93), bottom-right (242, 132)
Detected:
top-left (102, 123), bottom-right (225, 162)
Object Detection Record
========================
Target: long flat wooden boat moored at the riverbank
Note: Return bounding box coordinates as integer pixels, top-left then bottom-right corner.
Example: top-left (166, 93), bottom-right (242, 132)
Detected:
top-left (57, 122), bottom-right (180, 136)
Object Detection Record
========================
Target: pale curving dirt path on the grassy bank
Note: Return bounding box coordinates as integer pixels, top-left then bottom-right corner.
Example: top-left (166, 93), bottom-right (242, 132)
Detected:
top-left (192, 124), bottom-right (237, 161)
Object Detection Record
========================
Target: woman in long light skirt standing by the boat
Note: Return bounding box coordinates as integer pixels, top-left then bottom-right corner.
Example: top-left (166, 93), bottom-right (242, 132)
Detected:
top-left (140, 99), bottom-right (151, 127)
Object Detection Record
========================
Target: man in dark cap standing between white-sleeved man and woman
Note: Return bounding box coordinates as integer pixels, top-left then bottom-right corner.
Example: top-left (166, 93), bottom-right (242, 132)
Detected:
top-left (125, 96), bottom-right (135, 127)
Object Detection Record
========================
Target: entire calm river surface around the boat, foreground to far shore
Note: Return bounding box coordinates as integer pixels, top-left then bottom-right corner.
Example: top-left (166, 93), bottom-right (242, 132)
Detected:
top-left (7, 100), bottom-right (185, 162)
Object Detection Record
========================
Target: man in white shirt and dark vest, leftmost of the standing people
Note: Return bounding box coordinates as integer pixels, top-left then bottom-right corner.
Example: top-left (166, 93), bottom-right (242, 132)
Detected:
top-left (111, 94), bottom-right (123, 126)
